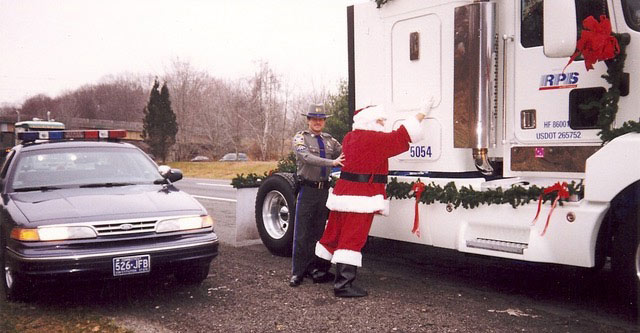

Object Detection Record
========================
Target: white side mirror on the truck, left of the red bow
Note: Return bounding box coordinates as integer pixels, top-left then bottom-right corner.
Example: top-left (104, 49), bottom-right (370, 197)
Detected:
top-left (542, 0), bottom-right (578, 58)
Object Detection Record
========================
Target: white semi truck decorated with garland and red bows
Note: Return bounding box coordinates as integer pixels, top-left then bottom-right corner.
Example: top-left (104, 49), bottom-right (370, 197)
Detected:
top-left (256, 0), bottom-right (640, 304)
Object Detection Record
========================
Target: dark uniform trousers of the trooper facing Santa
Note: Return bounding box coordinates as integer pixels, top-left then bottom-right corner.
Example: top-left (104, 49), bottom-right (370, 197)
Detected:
top-left (292, 185), bottom-right (331, 277)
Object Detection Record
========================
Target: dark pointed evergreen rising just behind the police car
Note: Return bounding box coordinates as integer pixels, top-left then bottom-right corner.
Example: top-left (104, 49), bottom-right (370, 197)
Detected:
top-left (142, 79), bottom-right (178, 163)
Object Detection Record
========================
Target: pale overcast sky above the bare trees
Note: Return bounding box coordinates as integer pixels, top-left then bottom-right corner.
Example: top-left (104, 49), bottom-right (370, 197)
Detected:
top-left (0, 0), bottom-right (367, 105)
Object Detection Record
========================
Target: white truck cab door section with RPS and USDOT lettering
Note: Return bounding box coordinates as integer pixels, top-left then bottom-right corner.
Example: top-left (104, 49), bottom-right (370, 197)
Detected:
top-left (505, 0), bottom-right (609, 175)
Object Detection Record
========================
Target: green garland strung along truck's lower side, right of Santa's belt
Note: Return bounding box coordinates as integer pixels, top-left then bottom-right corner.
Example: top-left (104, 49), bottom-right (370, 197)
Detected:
top-left (387, 177), bottom-right (584, 208)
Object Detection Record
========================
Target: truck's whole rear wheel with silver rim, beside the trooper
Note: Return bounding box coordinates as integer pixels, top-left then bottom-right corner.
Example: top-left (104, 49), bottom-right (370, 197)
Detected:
top-left (256, 173), bottom-right (296, 256)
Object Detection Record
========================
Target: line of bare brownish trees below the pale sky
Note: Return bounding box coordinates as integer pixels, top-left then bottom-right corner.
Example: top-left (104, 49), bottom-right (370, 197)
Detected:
top-left (0, 59), bottom-right (349, 161)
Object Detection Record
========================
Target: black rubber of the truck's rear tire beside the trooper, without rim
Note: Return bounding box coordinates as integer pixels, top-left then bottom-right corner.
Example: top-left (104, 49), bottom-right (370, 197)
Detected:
top-left (255, 173), bottom-right (296, 257)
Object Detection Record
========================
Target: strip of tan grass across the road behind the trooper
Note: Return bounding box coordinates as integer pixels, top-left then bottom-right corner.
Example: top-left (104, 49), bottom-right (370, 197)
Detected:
top-left (168, 161), bottom-right (278, 180)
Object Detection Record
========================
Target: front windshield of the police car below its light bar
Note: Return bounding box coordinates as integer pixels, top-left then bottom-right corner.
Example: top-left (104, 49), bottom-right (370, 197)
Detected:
top-left (9, 147), bottom-right (160, 191)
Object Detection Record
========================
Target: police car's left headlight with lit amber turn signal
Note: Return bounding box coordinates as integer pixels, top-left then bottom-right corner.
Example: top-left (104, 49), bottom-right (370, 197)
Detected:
top-left (11, 226), bottom-right (97, 242)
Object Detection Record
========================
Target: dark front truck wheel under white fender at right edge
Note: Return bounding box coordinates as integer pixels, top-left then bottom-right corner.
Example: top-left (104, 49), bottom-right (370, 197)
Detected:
top-left (611, 183), bottom-right (640, 309)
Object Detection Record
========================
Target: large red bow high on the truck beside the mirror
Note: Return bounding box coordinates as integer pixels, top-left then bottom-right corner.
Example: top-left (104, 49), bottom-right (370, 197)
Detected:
top-left (562, 15), bottom-right (620, 72)
